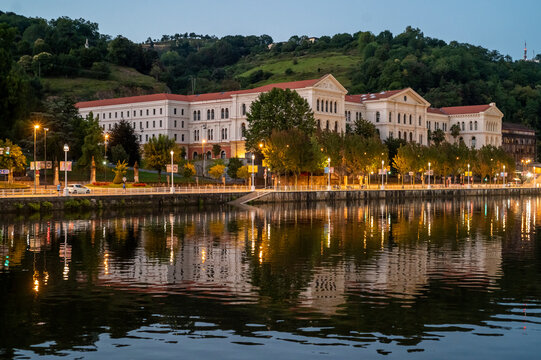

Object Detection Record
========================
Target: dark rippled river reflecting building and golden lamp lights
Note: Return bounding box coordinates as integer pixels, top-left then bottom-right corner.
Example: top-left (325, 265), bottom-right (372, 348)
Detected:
top-left (0, 198), bottom-right (541, 359)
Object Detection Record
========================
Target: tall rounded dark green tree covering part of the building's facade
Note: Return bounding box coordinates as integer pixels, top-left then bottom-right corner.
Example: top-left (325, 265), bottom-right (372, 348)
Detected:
top-left (245, 88), bottom-right (316, 151)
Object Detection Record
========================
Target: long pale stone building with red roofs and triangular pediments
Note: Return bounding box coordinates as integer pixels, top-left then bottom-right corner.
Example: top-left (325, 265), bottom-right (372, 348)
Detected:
top-left (76, 74), bottom-right (503, 159)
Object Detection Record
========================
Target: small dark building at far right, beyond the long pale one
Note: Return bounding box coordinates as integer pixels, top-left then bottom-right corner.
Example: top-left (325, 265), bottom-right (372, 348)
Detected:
top-left (502, 122), bottom-right (537, 165)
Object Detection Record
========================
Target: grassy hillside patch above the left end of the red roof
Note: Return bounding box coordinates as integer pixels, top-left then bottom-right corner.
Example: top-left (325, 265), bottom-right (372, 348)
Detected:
top-left (42, 65), bottom-right (167, 100)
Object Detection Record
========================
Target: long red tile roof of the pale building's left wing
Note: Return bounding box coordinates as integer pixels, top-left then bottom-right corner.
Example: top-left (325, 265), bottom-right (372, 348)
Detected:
top-left (75, 79), bottom-right (321, 108)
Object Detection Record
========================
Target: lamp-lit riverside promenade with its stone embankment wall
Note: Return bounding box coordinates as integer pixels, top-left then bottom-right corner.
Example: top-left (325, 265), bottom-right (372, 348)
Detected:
top-left (0, 185), bottom-right (541, 212)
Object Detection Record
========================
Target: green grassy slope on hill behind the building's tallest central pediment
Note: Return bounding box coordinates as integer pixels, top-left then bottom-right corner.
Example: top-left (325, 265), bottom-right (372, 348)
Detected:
top-left (235, 52), bottom-right (360, 88)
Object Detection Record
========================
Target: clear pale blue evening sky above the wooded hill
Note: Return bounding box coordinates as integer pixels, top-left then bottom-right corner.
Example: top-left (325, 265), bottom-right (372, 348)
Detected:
top-left (4, 0), bottom-right (541, 59)
